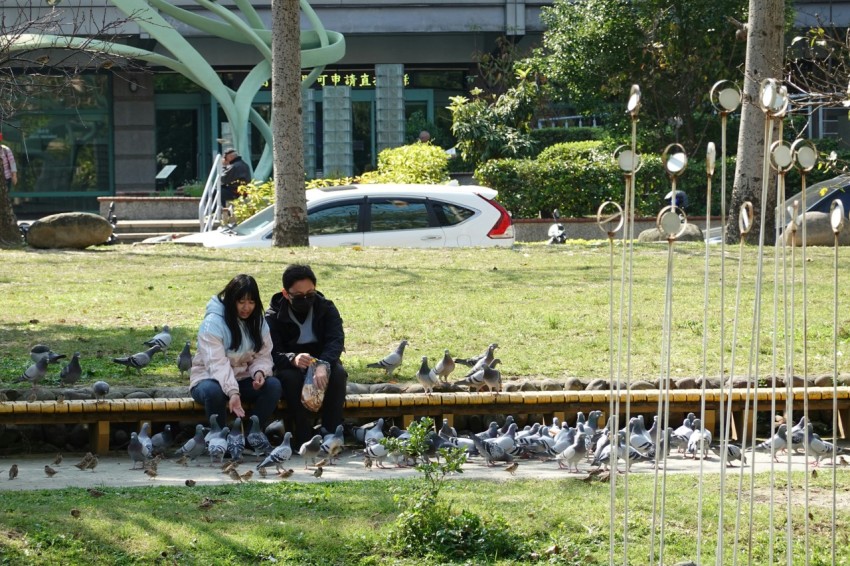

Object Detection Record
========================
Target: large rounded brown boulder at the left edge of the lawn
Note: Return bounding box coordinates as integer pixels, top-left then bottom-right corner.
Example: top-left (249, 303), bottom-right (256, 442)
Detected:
top-left (27, 212), bottom-right (112, 249)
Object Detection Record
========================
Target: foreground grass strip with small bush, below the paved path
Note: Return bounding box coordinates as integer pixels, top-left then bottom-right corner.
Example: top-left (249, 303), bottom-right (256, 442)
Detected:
top-left (0, 478), bottom-right (850, 565)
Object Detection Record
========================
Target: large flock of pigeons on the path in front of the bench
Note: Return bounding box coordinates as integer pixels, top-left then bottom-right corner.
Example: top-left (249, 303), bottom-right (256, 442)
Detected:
top-left (9, 411), bottom-right (850, 485)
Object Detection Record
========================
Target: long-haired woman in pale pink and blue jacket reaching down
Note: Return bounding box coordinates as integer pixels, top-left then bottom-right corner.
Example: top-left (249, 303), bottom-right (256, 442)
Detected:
top-left (189, 274), bottom-right (281, 426)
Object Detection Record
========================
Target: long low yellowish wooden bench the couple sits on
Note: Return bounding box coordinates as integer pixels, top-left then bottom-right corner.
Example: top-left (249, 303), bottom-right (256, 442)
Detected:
top-left (0, 387), bottom-right (850, 454)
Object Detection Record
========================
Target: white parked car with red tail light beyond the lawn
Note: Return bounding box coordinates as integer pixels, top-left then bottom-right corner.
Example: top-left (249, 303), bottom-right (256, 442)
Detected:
top-left (174, 184), bottom-right (514, 248)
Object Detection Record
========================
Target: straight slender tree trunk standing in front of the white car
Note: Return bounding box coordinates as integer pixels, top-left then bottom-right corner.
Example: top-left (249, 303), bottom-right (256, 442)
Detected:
top-left (272, 0), bottom-right (309, 247)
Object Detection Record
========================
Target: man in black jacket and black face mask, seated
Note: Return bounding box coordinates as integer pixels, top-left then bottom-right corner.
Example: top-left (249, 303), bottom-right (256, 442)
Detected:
top-left (266, 264), bottom-right (348, 447)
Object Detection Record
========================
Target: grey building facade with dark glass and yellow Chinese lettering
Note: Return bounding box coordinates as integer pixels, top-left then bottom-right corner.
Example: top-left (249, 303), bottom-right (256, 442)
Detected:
top-left (0, 0), bottom-right (548, 218)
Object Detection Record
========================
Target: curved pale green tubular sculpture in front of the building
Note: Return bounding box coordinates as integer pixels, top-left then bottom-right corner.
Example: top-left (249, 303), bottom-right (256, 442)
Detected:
top-left (5, 0), bottom-right (345, 179)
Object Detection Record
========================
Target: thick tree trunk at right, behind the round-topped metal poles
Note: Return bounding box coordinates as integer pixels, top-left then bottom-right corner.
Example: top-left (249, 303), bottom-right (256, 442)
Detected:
top-left (726, 0), bottom-right (785, 244)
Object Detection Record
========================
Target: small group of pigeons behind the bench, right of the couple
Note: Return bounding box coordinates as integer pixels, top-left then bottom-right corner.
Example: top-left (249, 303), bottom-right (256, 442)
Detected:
top-left (366, 340), bottom-right (502, 395)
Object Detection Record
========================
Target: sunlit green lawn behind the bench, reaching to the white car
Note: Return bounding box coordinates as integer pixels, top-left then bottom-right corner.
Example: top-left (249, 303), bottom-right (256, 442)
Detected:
top-left (0, 242), bottom-right (850, 392)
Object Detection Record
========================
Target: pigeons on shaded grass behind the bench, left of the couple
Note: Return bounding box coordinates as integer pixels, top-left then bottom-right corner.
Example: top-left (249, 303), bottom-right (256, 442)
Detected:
top-left (12, 325), bottom-right (192, 399)
